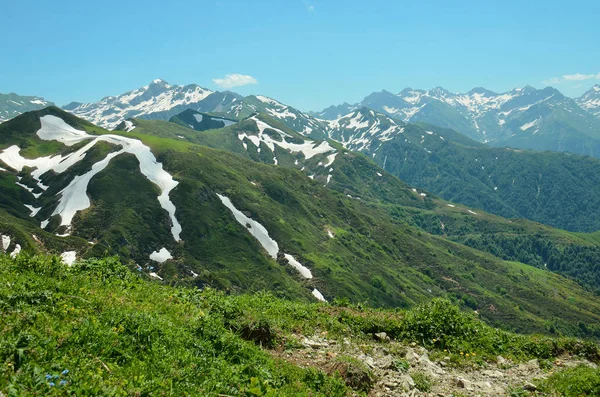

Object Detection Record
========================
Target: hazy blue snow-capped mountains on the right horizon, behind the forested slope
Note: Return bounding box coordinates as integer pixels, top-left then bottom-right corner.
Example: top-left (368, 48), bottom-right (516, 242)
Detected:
top-left (318, 86), bottom-right (600, 156)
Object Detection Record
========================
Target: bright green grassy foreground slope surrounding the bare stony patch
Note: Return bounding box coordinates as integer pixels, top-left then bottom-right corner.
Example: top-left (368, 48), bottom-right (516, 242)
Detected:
top-left (0, 256), bottom-right (600, 396)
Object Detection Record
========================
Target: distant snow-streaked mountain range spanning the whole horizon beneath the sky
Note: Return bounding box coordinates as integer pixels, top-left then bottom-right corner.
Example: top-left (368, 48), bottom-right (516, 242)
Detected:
top-left (0, 79), bottom-right (600, 157)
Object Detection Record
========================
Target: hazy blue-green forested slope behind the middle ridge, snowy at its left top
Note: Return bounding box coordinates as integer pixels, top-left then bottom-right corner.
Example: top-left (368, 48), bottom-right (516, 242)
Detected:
top-left (330, 109), bottom-right (600, 232)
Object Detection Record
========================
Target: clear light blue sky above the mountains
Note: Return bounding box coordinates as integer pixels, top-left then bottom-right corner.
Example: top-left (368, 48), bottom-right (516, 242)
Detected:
top-left (0, 0), bottom-right (600, 110)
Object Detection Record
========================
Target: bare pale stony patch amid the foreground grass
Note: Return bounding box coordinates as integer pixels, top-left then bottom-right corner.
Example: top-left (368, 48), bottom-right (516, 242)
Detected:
top-left (271, 333), bottom-right (596, 397)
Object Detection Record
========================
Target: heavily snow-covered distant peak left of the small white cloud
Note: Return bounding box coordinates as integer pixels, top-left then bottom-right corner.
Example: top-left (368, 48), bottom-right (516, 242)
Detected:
top-left (63, 79), bottom-right (213, 129)
